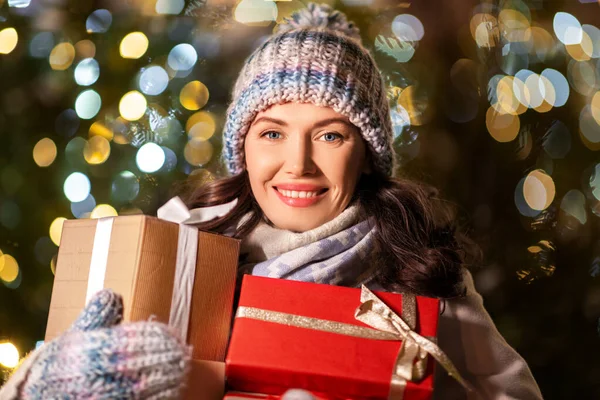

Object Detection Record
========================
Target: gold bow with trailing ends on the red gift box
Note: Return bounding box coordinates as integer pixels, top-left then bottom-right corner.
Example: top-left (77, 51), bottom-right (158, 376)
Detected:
top-left (354, 285), bottom-right (473, 400)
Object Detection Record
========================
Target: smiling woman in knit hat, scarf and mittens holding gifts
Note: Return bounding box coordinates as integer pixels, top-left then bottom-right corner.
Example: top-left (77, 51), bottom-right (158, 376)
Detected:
top-left (1, 4), bottom-right (541, 399)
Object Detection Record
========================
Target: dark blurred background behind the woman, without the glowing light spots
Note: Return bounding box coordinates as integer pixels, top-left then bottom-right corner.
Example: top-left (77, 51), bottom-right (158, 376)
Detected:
top-left (0, 0), bottom-right (600, 399)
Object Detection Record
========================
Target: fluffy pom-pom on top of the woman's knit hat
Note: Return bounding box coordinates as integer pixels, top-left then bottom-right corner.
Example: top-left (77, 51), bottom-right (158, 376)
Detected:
top-left (277, 3), bottom-right (360, 42)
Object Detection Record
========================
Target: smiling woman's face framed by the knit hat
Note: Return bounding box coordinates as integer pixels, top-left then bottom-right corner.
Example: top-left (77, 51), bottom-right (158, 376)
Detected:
top-left (244, 103), bottom-right (368, 232)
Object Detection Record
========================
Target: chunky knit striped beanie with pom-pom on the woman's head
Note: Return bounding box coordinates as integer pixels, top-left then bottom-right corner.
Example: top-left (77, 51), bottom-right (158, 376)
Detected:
top-left (223, 3), bottom-right (395, 176)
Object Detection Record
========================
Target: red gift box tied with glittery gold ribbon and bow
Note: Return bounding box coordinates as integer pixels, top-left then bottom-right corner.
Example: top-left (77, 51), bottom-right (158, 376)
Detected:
top-left (226, 275), bottom-right (468, 400)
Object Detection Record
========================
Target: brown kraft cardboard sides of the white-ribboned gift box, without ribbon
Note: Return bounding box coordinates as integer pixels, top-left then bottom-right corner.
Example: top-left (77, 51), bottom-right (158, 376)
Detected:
top-left (45, 215), bottom-right (239, 361)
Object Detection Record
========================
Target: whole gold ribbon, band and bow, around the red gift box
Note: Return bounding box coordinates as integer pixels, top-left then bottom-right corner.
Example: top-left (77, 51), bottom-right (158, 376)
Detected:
top-left (236, 286), bottom-right (473, 400)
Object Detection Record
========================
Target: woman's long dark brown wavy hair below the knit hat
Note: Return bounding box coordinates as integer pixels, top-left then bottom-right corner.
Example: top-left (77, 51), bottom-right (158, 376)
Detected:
top-left (178, 171), bottom-right (480, 298)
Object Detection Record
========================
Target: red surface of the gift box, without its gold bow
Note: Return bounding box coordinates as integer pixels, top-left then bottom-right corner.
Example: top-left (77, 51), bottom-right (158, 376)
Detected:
top-left (225, 275), bottom-right (450, 400)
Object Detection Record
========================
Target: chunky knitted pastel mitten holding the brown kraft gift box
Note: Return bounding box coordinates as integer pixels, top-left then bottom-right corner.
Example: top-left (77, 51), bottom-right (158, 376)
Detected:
top-left (0, 289), bottom-right (189, 400)
